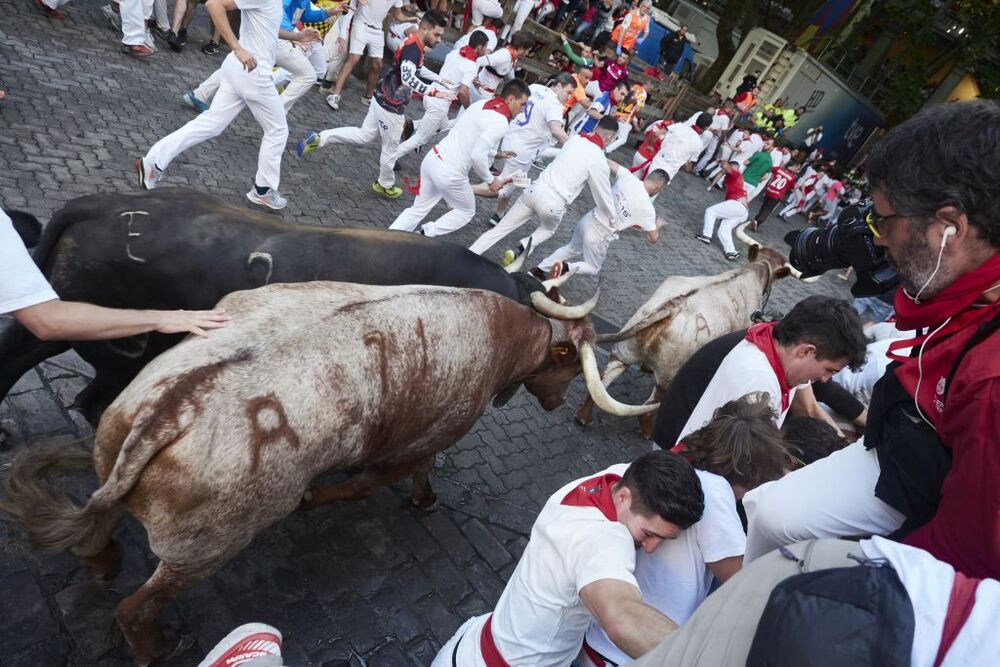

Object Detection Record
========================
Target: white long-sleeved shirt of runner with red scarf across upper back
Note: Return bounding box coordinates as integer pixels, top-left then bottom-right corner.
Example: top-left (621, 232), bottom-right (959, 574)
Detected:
top-left (432, 100), bottom-right (509, 183)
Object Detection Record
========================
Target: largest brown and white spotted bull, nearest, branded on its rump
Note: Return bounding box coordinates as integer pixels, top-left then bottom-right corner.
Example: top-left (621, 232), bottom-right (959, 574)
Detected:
top-left (0, 282), bottom-right (648, 664)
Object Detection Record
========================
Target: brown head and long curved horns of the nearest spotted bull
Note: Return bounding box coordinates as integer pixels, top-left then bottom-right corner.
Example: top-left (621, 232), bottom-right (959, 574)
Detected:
top-left (524, 286), bottom-right (659, 417)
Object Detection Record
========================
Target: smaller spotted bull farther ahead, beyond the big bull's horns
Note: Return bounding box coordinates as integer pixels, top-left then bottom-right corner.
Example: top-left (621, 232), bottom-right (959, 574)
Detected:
top-left (576, 245), bottom-right (789, 438)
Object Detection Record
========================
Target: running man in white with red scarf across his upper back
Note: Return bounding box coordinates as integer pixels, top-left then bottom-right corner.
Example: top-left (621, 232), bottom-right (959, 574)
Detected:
top-left (389, 79), bottom-right (529, 236)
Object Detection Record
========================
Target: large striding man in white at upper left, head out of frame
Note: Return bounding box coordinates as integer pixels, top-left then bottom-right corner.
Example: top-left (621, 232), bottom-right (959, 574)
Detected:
top-left (135, 0), bottom-right (290, 209)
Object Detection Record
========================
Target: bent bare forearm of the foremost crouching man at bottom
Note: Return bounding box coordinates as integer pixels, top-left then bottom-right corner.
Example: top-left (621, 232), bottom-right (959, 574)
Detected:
top-left (580, 579), bottom-right (677, 658)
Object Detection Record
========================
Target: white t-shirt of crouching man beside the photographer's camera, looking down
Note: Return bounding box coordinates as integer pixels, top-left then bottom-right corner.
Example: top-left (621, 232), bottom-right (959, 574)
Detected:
top-left (674, 340), bottom-right (795, 444)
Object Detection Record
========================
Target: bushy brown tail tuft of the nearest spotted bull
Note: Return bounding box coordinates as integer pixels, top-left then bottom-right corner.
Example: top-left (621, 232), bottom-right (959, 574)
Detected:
top-left (0, 445), bottom-right (124, 561)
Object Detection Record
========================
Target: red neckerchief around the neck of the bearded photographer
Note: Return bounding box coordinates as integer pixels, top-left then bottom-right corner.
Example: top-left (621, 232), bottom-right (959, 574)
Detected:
top-left (887, 252), bottom-right (1000, 421)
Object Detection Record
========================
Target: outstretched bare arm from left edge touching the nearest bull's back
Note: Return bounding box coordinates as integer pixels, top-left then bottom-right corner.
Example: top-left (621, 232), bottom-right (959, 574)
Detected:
top-left (14, 299), bottom-right (230, 340)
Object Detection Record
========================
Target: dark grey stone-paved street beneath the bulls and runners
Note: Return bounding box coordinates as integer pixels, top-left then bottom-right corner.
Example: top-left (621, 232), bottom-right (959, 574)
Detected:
top-left (0, 0), bottom-right (847, 666)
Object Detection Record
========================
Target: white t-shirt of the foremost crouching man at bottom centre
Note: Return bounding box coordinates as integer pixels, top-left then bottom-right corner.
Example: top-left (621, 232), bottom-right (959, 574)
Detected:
top-left (492, 464), bottom-right (638, 667)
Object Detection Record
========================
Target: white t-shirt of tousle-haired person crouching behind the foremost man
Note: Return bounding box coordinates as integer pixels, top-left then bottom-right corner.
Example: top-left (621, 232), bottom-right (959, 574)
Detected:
top-left (587, 470), bottom-right (746, 665)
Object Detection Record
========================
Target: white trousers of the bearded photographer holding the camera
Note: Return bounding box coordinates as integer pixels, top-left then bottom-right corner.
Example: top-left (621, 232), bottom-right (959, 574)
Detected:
top-left (743, 439), bottom-right (906, 563)
